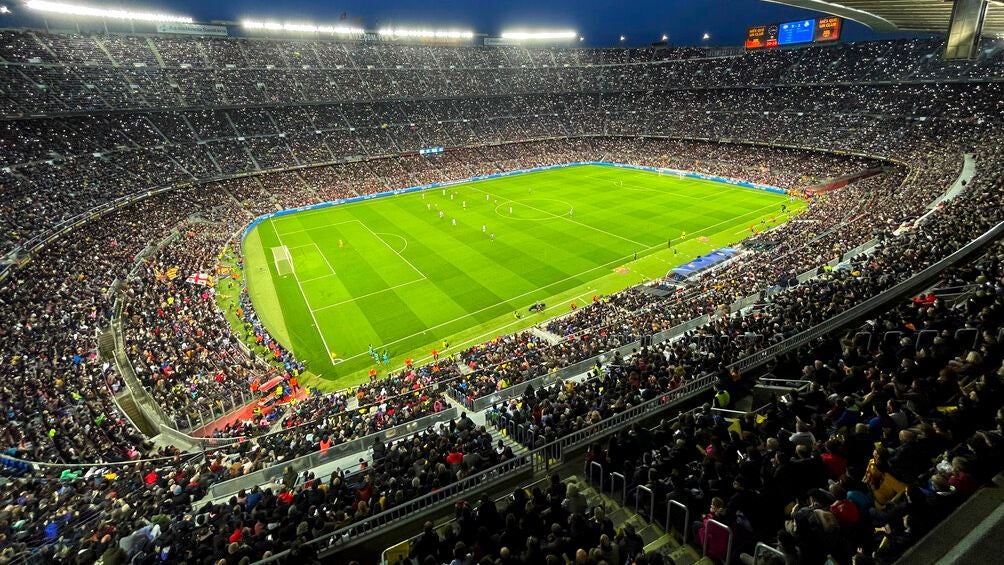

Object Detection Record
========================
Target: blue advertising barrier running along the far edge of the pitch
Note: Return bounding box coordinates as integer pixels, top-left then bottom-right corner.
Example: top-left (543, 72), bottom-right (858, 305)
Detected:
top-left (241, 161), bottom-right (788, 242)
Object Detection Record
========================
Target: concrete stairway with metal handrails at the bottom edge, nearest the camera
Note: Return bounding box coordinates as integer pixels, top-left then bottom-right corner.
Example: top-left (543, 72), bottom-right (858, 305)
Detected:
top-left (568, 477), bottom-right (714, 565)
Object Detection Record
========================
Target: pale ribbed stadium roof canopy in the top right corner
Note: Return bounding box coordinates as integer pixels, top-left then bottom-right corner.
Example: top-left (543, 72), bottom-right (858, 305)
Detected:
top-left (767, 0), bottom-right (1004, 33)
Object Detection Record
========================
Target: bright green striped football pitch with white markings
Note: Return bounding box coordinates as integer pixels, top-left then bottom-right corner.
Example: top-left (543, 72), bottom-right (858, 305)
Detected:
top-left (243, 166), bottom-right (805, 389)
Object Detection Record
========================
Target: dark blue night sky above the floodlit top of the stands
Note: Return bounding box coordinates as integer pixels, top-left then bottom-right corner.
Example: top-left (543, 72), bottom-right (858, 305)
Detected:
top-left (17, 0), bottom-right (923, 46)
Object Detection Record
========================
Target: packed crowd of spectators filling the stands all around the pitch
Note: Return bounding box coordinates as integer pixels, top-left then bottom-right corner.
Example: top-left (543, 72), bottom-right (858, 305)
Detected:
top-left (0, 31), bottom-right (1004, 565)
